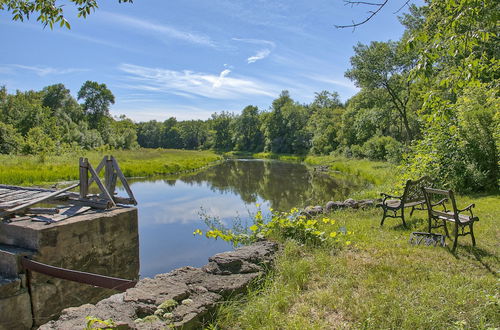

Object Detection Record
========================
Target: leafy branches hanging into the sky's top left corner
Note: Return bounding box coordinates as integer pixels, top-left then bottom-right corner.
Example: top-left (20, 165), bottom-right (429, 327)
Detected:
top-left (0, 0), bottom-right (132, 29)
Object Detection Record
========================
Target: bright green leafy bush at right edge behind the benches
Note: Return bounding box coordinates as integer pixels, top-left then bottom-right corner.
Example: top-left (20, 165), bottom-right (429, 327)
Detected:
top-left (404, 87), bottom-right (500, 192)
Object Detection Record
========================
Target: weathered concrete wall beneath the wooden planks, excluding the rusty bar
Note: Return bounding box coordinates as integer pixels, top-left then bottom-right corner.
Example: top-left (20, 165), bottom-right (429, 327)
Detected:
top-left (0, 208), bottom-right (139, 329)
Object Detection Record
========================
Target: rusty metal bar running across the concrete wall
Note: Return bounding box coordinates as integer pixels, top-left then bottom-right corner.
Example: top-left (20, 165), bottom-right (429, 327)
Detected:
top-left (21, 257), bottom-right (137, 291)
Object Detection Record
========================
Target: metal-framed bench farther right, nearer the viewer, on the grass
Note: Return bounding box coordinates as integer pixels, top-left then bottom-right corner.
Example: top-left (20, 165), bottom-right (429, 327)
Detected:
top-left (422, 188), bottom-right (479, 252)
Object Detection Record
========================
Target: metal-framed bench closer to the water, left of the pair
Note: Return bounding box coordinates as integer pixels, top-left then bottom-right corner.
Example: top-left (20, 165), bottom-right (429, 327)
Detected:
top-left (377, 176), bottom-right (431, 227)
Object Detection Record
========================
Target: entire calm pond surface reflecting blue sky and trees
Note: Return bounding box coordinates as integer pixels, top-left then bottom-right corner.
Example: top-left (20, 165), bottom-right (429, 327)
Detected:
top-left (120, 159), bottom-right (366, 277)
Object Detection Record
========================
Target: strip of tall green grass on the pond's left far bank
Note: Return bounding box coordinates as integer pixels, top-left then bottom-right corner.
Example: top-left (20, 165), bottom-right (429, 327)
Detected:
top-left (0, 149), bottom-right (222, 185)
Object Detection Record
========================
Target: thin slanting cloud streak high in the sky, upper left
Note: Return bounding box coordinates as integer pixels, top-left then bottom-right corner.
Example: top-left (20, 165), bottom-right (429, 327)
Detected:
top-left (103, 12), bottom-right (216, 47)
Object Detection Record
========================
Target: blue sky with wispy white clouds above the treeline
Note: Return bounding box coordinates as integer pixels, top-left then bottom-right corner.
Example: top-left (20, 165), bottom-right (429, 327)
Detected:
top-left (0, 0), bottom-right (414, 121)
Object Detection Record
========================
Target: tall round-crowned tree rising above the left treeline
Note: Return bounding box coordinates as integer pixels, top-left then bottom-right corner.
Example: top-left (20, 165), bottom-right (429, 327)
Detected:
top-left (78, 80), bottom-right (115, 128)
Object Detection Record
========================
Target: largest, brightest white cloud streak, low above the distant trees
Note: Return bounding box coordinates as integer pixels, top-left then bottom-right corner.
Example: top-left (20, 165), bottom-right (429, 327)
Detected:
top-left (118, 64), bottom-right (279, 99)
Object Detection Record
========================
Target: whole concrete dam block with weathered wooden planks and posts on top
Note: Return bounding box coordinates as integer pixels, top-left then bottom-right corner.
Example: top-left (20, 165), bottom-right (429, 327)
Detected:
top-left (0, 156), bottom-right (139, 330)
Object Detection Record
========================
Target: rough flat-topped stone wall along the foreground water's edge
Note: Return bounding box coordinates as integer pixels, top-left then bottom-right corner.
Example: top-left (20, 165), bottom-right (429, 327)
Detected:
top-left (39, 241), bottom-right (278, 330)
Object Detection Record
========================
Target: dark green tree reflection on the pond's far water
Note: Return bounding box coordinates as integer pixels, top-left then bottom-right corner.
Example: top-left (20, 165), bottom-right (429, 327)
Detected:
top-left (181, 160), bottom-right (364, 210)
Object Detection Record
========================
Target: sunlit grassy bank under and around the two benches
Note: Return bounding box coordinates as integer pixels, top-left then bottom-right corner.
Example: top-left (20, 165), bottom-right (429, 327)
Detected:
top-left (208, 157), bottom-right (500, 329)
